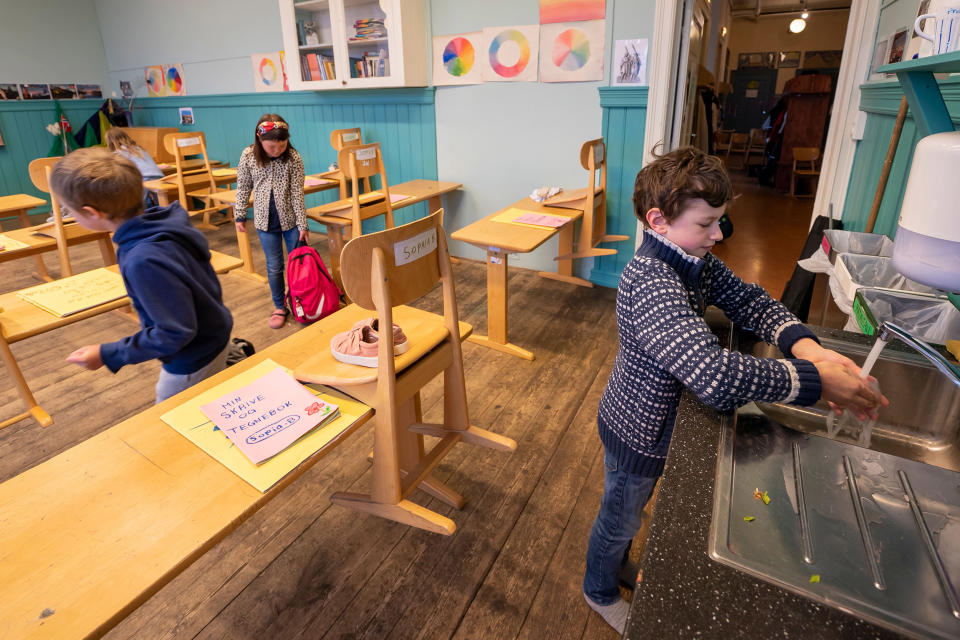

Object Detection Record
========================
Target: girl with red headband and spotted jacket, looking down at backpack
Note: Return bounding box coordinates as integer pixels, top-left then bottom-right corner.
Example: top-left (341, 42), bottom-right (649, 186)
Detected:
top-left (234, 113), bottom-right (309, 329)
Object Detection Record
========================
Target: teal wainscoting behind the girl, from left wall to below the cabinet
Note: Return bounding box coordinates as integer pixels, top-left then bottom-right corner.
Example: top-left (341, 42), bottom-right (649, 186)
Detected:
top-left (0, 87), bottom-right (437, 231)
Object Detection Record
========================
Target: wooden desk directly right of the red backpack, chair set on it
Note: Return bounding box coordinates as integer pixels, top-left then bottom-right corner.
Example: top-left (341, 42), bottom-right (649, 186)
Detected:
top-left (307, 179), bottom-right (463, 283)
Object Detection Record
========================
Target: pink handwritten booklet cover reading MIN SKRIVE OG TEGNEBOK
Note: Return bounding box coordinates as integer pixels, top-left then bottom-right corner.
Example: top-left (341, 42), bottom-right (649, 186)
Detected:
top-left (200, 367), bottom-right (339, 464)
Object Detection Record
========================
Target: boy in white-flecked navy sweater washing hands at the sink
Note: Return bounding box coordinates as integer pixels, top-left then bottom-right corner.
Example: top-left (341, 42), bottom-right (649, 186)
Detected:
top-left (583, 147), bottom-right (888, 633)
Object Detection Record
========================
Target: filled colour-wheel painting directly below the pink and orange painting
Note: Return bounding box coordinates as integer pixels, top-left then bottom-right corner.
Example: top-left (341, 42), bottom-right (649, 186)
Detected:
top-left (540, 20), bottom-right (606, 82)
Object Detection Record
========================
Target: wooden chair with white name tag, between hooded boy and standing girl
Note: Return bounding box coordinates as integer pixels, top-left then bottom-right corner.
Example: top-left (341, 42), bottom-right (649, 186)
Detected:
top-left (163, 131), bottom-right (233, 231)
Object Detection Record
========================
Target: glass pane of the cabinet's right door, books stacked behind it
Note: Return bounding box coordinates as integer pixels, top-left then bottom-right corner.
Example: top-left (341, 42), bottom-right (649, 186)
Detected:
top-left (343, 0), bottom-right (390, 78)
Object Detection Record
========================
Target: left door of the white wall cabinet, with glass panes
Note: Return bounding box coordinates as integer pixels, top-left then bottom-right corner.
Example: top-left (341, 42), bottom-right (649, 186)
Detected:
top-left (279, 0), bottom-right (344, 90)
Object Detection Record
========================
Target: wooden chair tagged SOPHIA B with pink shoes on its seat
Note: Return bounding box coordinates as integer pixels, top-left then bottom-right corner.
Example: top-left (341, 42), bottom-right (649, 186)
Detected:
top-left (294, 209), bottom-right (517, 535)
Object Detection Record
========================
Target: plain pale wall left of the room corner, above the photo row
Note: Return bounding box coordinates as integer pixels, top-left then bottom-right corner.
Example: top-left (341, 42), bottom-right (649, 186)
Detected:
top-left (0, 0), bottom-right (110, 90)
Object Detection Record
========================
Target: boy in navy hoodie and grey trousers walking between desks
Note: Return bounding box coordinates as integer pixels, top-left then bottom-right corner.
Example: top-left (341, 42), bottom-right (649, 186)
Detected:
top-left (50, 148), bottom-right (233, 403)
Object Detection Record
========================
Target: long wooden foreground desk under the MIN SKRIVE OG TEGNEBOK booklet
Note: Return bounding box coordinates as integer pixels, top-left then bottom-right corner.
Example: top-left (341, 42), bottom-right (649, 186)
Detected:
top-left (0, 307), bottom-right (470, 638)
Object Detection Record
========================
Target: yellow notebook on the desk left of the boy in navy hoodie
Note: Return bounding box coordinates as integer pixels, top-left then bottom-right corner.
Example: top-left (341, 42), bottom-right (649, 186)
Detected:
top-left (17, 267), bottom-right (127, 318)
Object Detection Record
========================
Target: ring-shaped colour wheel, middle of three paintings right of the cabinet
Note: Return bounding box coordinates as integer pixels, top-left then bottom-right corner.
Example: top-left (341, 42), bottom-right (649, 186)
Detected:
top-left (480, 24), bottom-right (540, 82)
